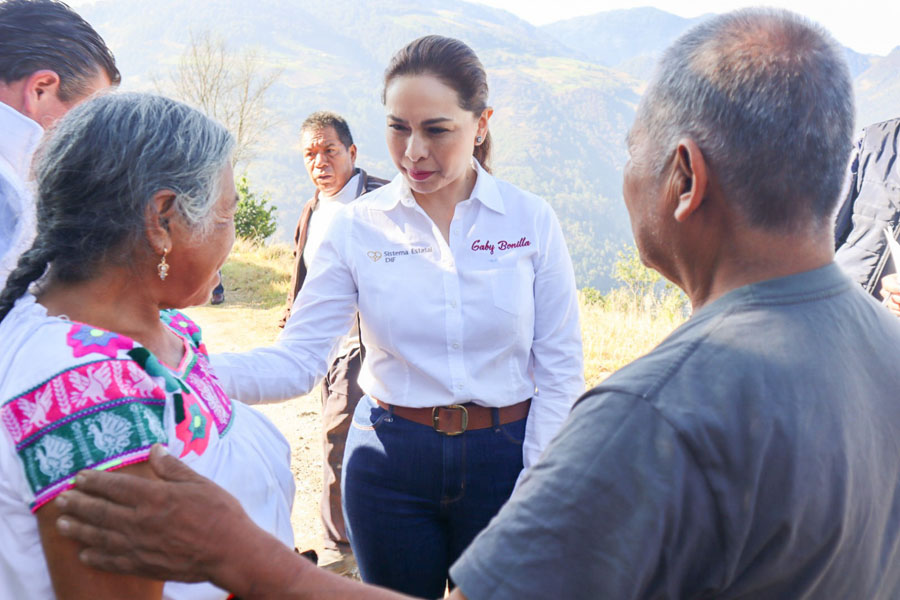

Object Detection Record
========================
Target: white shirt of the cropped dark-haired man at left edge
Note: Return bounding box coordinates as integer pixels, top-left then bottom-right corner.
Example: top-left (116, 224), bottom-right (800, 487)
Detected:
top-left (0, 102), bottom-right (44, 289)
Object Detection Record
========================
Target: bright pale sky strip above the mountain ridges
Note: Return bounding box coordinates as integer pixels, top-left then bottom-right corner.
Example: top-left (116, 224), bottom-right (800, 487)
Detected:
top-left (478, 0), bottom-right (900, 56)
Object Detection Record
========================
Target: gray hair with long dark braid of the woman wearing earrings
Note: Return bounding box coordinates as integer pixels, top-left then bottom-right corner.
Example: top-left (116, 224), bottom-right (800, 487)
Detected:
top-left (0, 93), bottom-right (234, 319)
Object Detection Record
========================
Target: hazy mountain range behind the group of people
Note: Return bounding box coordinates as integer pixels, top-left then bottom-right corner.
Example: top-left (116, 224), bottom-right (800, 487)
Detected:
top-left (80, 0), bottom-right (900, 289)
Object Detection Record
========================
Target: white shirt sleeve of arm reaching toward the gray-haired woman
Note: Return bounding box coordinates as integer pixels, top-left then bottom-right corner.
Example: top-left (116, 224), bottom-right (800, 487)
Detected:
top-left (211, 209), bottom-right (358, 404)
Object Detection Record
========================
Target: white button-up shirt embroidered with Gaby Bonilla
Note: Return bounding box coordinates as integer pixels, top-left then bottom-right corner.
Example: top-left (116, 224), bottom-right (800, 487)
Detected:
top-left (213, 161), bottom-right (584, 466)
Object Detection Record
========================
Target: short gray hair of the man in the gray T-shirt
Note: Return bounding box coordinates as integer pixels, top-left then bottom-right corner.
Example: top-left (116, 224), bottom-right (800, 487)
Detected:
top-left (635, 9), bottom-right (853, 231)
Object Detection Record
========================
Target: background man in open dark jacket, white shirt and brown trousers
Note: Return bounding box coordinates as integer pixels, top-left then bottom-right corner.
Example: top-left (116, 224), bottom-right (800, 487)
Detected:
top-left (281, 111), bottom-right (387, 575)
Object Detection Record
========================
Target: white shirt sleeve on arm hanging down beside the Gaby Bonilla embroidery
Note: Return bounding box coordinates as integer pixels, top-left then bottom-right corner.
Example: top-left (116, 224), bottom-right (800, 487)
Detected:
top-left (523, 203), bottom-right (584, 469)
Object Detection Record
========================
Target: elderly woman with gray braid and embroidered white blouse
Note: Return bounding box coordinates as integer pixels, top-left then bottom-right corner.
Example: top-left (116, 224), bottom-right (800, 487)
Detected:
top-left (0, 94), bottom-right (294, 600)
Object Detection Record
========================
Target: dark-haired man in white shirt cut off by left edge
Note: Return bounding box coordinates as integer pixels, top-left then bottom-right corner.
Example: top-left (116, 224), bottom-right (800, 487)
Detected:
top-left (0, 0), bottom-right (121, 289)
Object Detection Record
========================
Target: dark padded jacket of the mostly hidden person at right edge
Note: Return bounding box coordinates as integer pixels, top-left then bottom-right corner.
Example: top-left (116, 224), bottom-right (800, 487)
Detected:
top-left (834, 118), bottom-right (900, 297)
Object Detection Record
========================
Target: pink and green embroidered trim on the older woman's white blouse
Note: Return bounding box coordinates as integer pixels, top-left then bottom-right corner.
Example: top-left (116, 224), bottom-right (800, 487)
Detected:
top-left (0, 311), bottom-right (232, 510)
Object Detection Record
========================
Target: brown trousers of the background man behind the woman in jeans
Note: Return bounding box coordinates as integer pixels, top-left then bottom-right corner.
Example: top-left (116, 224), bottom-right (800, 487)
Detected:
top-left (321, 348), bottom-right (363, 552)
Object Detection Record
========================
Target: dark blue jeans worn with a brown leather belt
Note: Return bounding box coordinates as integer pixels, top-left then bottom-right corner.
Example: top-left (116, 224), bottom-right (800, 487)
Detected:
top-left (341, 396), bottom-right (526, 598)
